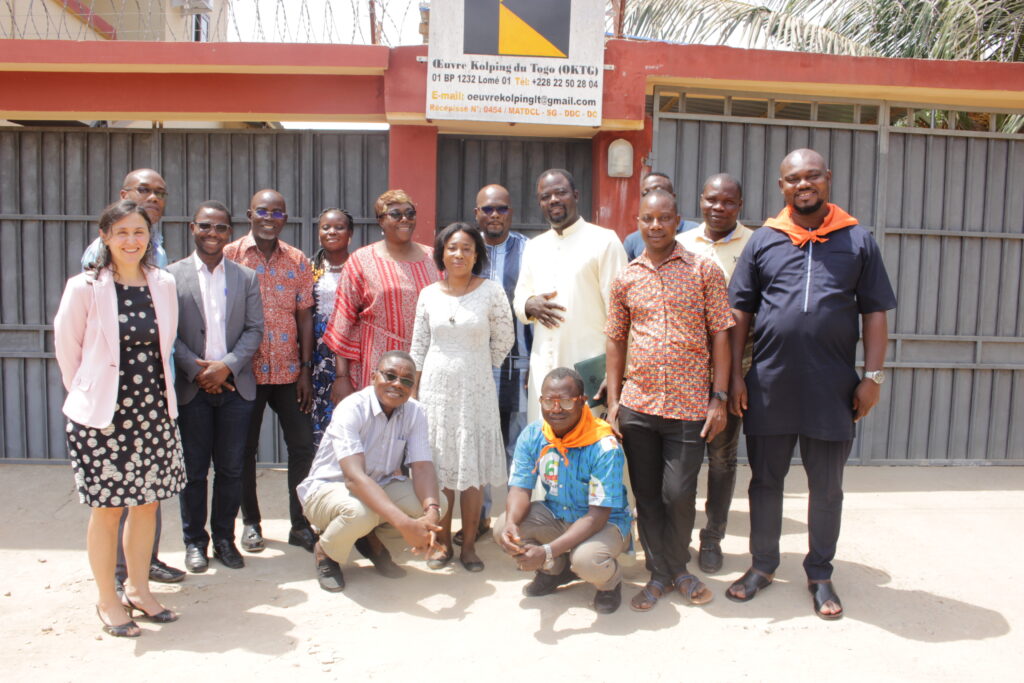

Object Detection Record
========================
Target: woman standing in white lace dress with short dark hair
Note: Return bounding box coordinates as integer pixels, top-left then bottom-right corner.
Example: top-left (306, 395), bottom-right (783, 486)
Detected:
top-left (411, 223), bottom-right (515, 571)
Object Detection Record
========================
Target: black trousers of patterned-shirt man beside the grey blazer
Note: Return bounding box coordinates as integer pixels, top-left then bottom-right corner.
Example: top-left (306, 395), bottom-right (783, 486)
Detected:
top-left (242, 382), bottom-right (313, 528)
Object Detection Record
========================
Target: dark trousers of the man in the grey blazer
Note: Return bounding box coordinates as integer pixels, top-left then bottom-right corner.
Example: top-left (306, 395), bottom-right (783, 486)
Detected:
top-left (178, 390), bottom-right (253, 549)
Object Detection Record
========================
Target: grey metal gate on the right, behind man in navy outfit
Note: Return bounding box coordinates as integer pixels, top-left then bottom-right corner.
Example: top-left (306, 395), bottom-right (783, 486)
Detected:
top-left (652, 88), bottom-right (1024, 464)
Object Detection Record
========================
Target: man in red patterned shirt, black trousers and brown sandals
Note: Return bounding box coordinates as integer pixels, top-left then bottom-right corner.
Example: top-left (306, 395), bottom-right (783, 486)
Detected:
top-left (604, 189), bottom-right (735, 611)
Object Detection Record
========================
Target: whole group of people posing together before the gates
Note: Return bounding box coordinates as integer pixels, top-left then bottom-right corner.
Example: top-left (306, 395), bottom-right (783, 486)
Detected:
top-left (54, 150), bottom-right (895, 636)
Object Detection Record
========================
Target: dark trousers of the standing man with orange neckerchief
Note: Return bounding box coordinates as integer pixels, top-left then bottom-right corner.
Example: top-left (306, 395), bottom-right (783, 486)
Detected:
top-left (746, 434), bottom-right (853, 581)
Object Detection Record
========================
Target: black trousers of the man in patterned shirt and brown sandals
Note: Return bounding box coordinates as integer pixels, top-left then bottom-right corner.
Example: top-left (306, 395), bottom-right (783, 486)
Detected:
top-left (618, 405), bottom-right (705, 586)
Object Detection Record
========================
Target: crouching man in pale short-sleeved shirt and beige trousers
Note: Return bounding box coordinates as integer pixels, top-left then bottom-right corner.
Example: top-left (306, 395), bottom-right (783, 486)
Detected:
top-left (298, 351), bottom-right (444, 593)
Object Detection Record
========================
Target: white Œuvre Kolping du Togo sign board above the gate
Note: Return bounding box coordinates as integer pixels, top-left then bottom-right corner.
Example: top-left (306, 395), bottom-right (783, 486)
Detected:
top-left (426, 0), bottom-right (604, 126)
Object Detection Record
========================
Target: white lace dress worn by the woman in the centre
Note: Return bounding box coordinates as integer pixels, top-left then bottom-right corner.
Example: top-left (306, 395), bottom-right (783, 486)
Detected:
top-left (410, 280), bottom-right (515, 490)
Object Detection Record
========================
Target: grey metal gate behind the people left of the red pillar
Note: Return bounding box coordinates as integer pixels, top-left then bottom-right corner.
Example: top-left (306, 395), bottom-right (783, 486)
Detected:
top-left (0, 128), bottom-right (387, 462)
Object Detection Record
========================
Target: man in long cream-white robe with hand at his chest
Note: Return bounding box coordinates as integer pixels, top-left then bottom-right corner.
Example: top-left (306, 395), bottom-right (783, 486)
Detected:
top-left (512, 169), bottom-right (627, 422)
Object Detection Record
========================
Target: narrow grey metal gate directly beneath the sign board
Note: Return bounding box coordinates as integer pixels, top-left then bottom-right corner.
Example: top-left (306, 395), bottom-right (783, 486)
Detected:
top-left (437, 135), bottom-right (591, 237)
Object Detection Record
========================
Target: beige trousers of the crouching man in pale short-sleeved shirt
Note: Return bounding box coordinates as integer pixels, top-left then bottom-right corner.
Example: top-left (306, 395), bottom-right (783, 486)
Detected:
top-left (302, 479), bottom-right (447, 563)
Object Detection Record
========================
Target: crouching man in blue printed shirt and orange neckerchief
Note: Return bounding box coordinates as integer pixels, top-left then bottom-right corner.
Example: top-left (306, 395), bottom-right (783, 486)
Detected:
top-left (494, 368), bottom-right (632, 614)
